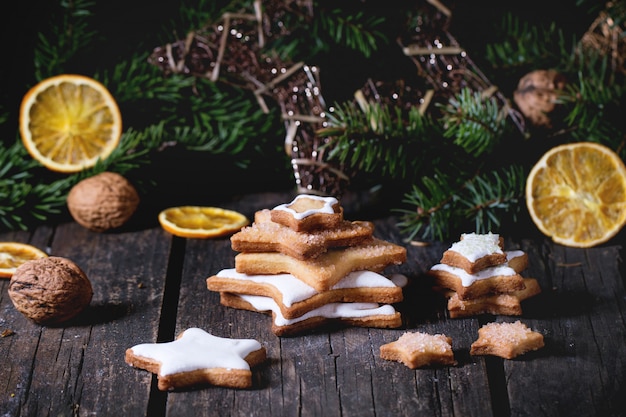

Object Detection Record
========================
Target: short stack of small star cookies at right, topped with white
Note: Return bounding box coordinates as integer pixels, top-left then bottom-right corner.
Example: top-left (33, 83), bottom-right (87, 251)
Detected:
top-left (428, 233), bottom-right (541, 318)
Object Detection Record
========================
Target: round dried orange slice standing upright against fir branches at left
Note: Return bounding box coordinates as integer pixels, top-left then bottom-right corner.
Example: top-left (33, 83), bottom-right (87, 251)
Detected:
top-left (20, 74), bottom-right (122, 173)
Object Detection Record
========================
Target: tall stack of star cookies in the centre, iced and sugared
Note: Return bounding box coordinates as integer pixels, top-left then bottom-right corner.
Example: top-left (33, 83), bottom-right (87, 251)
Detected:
top-left (207, 194), bottom-right (406, 336)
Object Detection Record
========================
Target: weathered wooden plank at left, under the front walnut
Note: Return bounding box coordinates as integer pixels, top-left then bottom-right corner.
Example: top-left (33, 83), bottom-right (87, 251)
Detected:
top-left (0, 223), bottom-right (171, 416)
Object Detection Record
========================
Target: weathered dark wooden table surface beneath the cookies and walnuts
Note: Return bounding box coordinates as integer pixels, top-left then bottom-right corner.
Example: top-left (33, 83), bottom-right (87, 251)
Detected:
top-left (0, 192), bottom-right (626, 417)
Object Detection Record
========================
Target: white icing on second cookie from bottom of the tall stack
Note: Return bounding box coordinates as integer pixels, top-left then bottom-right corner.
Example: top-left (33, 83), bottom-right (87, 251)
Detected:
top-left (216, 268), bottom-right (408, 307)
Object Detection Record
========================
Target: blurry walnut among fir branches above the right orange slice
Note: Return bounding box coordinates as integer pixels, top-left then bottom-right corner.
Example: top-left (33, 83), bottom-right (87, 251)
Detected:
top-left (513, 69), bottom-right (567, 129)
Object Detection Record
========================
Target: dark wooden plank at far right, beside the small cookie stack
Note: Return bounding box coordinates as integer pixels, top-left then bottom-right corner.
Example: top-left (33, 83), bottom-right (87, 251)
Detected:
top-left (502, 242), bottom-right (626, 416)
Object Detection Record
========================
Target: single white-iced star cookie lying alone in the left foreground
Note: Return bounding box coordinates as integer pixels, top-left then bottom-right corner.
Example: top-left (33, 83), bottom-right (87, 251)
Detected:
top-left (125, 328), bottom-right (266, 391)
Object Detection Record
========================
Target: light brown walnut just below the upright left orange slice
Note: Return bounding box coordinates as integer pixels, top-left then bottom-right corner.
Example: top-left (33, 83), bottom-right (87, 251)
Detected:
top-left (67, 172), bottom-right (139, 232)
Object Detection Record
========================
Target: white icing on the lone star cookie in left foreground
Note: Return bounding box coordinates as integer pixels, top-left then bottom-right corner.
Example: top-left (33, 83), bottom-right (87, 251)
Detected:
top-left (131, 327), bottom-right (262, 375)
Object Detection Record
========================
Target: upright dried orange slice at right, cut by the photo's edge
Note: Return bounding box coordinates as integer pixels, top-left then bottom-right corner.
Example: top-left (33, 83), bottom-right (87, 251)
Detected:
top-left (526, 142), bottom-right (626, 248)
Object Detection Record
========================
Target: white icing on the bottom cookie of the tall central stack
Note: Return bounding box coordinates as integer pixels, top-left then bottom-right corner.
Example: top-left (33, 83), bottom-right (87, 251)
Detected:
top-left (237, 294), bottom-right (396, 326)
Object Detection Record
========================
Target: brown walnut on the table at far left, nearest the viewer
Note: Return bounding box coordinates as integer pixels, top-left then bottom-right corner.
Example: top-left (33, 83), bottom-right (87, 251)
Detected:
top-left (8, 256), bottom-right (93, 325)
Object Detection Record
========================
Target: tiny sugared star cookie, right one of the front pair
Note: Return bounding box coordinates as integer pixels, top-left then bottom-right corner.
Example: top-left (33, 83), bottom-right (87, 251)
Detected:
top-left (470, 320), bottom-right (544, 359)
